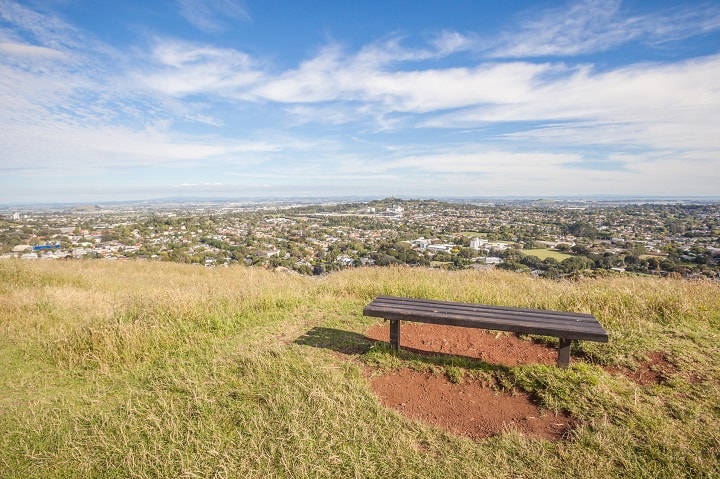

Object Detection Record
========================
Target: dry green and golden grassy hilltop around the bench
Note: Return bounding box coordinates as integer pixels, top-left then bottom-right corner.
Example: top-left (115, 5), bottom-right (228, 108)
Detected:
top-left (0, 261), bottom-right (720, 478)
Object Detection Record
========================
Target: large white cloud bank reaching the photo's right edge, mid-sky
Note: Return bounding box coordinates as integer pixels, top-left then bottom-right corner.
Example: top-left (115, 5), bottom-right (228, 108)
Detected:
top-left (428, 56), bottom-right (720, 150)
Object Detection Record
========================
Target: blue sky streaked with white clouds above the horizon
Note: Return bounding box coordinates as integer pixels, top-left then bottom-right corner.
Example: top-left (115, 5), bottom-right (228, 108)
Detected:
top-left (0, 0), bottom-right (720, 204)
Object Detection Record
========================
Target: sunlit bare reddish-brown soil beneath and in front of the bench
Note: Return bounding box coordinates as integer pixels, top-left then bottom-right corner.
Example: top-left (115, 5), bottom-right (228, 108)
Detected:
top-left (366, 323), bottom-right (571, 440)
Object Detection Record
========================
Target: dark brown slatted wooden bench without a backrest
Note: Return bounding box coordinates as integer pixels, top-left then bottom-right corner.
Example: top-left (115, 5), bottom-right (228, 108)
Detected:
top-left (363, 296), bottom-right (608, 367)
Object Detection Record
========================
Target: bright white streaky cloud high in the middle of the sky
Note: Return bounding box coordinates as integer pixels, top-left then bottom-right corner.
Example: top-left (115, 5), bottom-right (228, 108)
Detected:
top-left (252, 41), bottom-right (553, 112)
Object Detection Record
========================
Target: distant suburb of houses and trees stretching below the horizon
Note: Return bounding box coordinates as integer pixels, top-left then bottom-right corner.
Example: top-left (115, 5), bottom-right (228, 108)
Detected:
top-left (0, 198), bottom-right (720, 278)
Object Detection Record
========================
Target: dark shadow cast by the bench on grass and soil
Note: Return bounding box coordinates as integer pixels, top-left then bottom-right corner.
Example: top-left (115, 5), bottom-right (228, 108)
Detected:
top-left (293, 326), bottom-right (509, 370)
